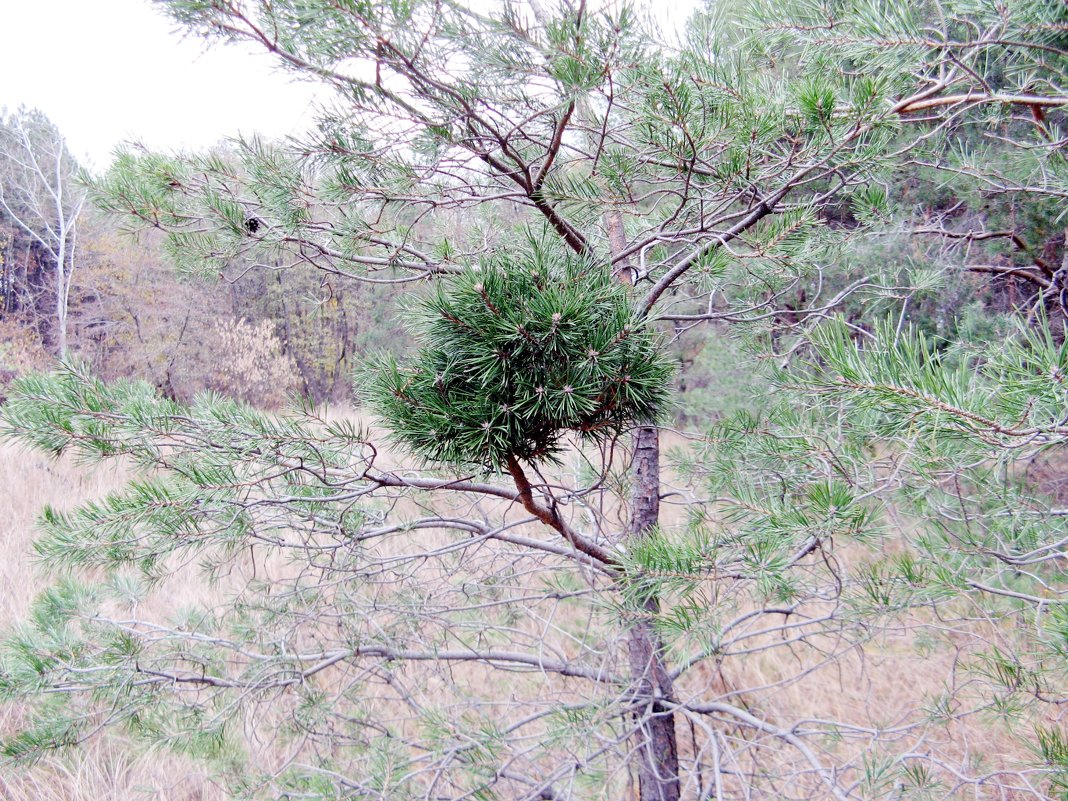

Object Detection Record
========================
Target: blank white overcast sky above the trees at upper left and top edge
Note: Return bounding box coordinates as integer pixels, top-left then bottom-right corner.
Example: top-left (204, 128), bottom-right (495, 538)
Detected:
top-left (0, 0), bottom-right (694, 171)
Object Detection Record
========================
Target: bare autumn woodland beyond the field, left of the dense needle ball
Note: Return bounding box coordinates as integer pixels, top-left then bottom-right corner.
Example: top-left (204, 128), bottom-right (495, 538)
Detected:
top-left (0, 110), bottom-right (398, 408)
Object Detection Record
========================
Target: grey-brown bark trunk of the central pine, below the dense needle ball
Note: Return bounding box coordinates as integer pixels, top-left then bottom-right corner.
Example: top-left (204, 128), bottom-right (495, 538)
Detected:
top-left (628, 426), bottom-right (680, 801)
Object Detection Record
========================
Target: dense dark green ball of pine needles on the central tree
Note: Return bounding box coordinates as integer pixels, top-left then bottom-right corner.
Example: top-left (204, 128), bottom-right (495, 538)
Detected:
top-left (363, 244), bottom-right (673, 469)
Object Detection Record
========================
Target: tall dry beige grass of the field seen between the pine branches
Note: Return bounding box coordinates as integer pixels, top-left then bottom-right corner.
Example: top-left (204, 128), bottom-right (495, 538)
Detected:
top-left (0, 433), bottom-right (1042, 801)
